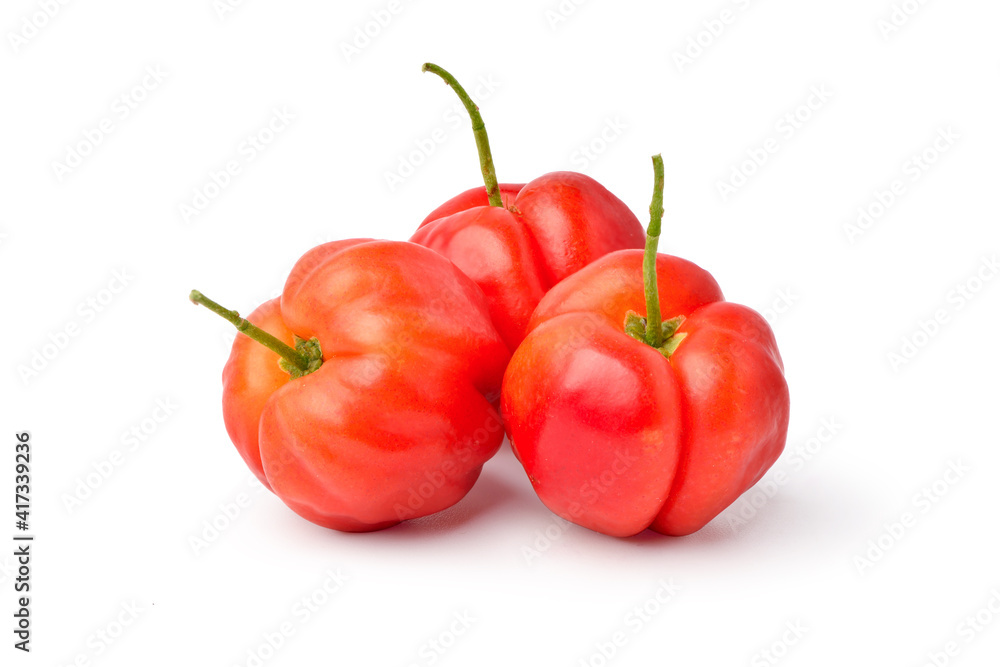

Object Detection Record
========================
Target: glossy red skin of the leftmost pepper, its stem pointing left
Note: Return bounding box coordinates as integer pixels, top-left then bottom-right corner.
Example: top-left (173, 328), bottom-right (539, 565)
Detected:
top-left (223, 239), bottom-right (509, 532)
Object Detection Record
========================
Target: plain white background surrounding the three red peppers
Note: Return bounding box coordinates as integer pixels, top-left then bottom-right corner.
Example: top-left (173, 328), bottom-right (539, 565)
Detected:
top-left (0, 0), bottom-right (1000, 666)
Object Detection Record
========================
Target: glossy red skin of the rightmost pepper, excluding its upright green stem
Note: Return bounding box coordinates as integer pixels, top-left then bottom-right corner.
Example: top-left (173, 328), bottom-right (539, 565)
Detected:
top-left (501, 250), bottom-right (789, 537)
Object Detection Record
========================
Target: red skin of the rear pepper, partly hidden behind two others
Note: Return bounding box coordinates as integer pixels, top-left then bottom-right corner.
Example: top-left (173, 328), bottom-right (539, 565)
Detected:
top-left (410, 171), bottom-right (646, 350)
